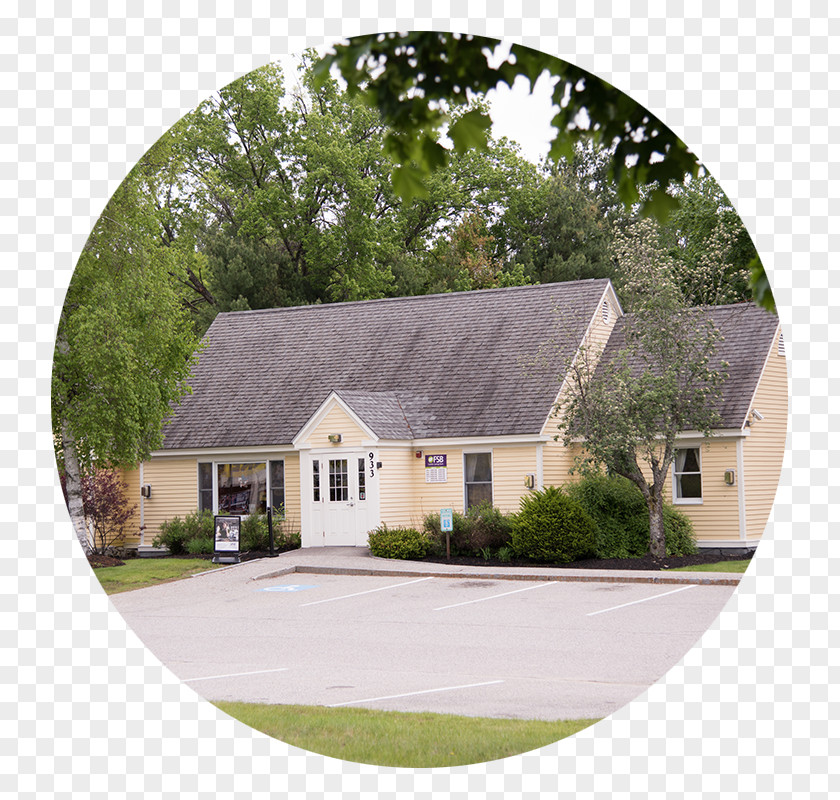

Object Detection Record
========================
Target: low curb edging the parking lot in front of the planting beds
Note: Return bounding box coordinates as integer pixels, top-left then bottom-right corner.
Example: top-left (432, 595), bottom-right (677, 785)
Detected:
top-left (246, 564), bottom-right (740, 586)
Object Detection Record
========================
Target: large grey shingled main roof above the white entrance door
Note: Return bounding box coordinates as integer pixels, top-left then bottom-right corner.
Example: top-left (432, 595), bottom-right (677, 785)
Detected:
top-left (164, 280), bottom-right (608, 449)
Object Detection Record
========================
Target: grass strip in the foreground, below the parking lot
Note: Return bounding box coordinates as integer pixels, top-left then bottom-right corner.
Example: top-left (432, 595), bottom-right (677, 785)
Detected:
top-left (214, 702), bottom-right (598, 767)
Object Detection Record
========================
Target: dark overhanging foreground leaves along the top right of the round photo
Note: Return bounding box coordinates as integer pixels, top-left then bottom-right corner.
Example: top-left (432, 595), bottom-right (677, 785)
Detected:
top-left (317, 31), bottom-right (775, 310)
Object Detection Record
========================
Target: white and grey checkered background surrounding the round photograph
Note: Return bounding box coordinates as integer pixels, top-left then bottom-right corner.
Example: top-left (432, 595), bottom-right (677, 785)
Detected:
top-left (0, 0), bottom-right (840, 800)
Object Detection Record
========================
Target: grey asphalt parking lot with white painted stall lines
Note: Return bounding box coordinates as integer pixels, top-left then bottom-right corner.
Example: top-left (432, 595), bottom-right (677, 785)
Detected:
top-left (111, 552), bottom-right (734, 719)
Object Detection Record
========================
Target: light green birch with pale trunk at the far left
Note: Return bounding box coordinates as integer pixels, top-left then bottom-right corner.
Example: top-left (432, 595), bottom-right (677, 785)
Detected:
top-left (52, 160), bottom-right (197, 552)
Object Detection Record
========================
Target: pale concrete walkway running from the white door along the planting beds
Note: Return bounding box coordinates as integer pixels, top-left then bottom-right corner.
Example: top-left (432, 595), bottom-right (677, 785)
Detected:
top-left (205, 547), bottom-right (741, 586)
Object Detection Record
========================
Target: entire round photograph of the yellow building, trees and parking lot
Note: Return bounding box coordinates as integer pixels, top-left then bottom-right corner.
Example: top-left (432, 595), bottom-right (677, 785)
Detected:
top-left (52, 32), bottom-right (787, 767)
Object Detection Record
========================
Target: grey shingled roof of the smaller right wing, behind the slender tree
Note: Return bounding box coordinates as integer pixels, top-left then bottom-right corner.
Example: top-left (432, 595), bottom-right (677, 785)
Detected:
top-left (602, 303), bottom-right (779, 428)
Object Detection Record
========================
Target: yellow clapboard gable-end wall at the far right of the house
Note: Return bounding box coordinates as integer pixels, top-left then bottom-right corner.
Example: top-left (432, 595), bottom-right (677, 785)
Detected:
top-left (744, 332), bottom-right (788, 541)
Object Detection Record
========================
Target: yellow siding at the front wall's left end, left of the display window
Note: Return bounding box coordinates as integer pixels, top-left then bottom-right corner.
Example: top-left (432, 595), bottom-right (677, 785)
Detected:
top-left (143, 457), bottom-right (198, 545)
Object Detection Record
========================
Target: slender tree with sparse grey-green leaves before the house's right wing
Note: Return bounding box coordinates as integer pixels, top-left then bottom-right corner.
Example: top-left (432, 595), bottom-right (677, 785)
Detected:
top-left (556, 221), bottom-right (727, 558)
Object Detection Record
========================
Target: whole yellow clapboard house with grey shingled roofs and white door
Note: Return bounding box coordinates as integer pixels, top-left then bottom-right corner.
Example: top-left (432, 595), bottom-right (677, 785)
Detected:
top-left (120, 280), bottom-right (787, 553)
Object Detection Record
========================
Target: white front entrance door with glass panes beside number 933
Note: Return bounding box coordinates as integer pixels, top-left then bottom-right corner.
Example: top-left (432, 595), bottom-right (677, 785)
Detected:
top-left (307, 450), bottom-right (377, 547)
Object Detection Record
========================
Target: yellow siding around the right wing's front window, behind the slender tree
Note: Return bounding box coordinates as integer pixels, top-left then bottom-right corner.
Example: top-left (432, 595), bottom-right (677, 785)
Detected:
top-left (662, 439), bottom-right (741, 542)
